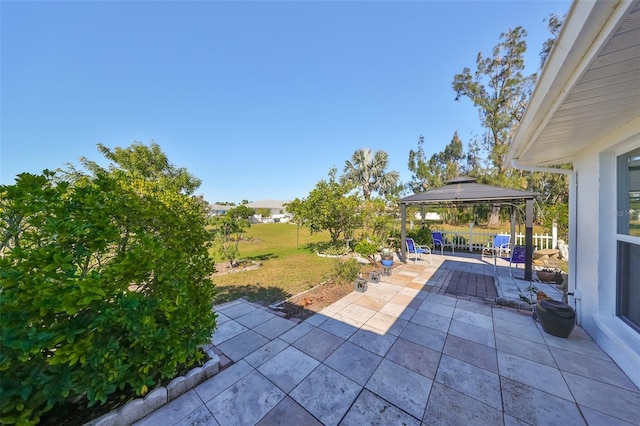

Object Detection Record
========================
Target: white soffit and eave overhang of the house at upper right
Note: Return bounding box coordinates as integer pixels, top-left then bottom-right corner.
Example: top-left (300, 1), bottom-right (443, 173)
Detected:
top-left (505, 0), bottom-right (640, 166)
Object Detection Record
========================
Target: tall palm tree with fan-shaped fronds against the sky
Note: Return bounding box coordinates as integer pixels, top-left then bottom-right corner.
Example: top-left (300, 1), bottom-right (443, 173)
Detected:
top-left (340, 148), bottom-right (400, 200)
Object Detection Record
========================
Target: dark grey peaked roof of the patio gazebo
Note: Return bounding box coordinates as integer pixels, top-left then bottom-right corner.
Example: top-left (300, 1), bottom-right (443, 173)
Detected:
top-left (400, 176), bottom-right (539, 204)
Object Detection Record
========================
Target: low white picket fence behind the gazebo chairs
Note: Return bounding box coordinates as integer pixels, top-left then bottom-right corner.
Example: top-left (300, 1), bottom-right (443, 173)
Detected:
top-left (433, 224), bottom-right (558, 252)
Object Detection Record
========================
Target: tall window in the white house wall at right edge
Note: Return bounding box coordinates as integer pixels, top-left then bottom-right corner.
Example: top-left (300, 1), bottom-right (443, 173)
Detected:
top-left (616, 148), bottom-right (640, 333)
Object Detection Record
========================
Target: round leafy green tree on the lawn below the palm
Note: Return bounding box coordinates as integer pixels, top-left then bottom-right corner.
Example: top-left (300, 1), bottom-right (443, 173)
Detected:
top-left (287, 168), bottom-right (362, 242)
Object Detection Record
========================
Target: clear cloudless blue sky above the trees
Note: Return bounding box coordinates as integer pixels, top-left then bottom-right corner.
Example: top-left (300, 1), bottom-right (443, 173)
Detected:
top-left (0, 1), bottom-right (570, 203)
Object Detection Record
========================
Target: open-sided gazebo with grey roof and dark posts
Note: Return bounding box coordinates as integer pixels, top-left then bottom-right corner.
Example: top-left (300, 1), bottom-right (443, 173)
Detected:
top-left (400, 176), bottom-right (539, 281)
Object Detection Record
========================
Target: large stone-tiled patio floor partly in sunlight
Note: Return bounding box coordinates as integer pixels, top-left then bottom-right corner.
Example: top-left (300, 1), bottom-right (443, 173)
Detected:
top-left (136, 253), bottom-right (640, 425)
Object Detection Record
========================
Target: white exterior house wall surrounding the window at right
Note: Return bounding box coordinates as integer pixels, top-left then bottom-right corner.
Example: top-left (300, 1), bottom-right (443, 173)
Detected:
top-left (570, 128), bottom-right (640, 386)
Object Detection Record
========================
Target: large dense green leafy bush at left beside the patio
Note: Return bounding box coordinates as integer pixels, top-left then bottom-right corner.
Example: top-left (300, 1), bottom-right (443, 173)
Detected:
top-left (0, 164), bottom-right (215, 424)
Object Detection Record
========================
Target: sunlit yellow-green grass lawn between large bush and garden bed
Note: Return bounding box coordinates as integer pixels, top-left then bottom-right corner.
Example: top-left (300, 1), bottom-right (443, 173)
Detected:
top-left (213, 223), bottom-right (336, 304)
